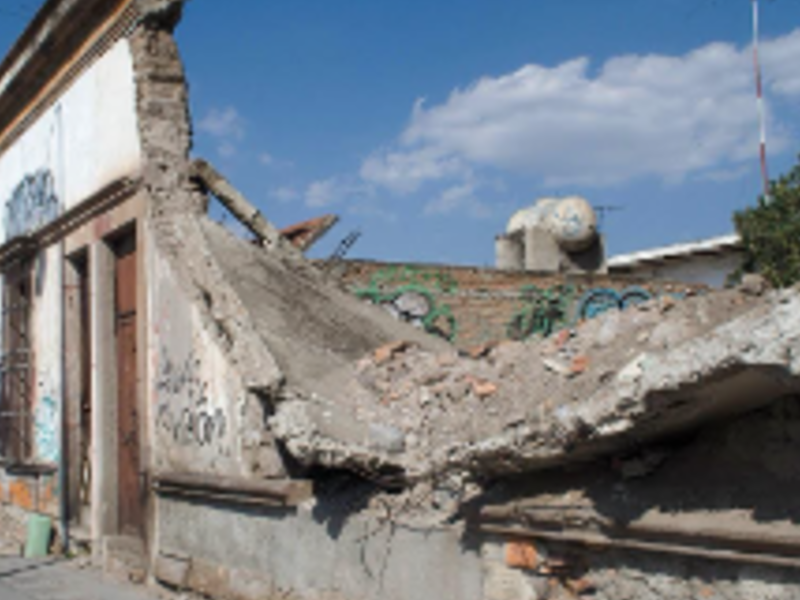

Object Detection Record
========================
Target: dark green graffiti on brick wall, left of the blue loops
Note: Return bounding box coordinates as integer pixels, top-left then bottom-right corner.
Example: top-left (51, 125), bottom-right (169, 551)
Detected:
top-left (506, 284), bottom-right (575, 341)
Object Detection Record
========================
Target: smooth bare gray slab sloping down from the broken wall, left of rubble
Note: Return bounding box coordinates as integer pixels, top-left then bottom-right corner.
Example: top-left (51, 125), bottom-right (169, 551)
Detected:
top-left (199, 218), bottom-right (449, 395)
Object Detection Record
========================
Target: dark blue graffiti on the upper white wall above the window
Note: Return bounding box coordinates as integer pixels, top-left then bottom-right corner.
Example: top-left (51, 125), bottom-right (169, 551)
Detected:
top-left (4, 169), bottom-right (60, 239)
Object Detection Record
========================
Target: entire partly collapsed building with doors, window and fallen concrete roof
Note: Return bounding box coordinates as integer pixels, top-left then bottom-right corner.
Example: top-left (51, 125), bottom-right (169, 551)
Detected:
top-left (0, 0), bottom-right (800, 600)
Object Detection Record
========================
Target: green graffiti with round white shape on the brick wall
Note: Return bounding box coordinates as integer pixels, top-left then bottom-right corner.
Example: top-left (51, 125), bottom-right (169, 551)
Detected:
top-left (355, 266), bottom-right (458, 342)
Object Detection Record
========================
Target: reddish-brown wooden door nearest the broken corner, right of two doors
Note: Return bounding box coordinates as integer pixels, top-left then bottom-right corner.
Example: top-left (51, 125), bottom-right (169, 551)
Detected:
top-left (115, 233), bottom-right (145, 536)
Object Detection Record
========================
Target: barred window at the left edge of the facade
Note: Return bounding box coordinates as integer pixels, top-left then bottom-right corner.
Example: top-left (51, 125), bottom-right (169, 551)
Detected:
top-left (0, 263), bottom-right (33, 464)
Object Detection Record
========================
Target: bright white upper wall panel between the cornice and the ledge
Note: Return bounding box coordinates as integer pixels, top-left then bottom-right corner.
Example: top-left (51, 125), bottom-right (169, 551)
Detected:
top-left (0, 40), bottom-right (141, 243)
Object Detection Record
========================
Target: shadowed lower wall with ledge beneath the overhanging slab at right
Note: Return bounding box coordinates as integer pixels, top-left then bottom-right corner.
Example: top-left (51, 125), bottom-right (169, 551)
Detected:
top-left (466, 397), bottom-right (800, 600)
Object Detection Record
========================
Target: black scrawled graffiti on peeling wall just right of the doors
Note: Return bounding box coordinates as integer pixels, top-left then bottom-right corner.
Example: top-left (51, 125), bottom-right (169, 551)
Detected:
top-left (156, 348), bottom-right (228, 447)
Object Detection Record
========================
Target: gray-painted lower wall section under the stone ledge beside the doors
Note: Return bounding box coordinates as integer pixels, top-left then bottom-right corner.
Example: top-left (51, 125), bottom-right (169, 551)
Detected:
top-left (158, 499), bottom-right (483, 600)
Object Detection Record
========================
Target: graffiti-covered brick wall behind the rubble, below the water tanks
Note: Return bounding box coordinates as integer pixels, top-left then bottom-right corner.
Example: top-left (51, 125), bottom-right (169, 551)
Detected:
top-left (331, 261), bottom-right (707, 348)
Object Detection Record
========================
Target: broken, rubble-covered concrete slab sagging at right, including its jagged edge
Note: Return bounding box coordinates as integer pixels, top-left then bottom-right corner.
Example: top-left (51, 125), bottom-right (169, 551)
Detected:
top-left (271, 290), bottom-right (800, 482)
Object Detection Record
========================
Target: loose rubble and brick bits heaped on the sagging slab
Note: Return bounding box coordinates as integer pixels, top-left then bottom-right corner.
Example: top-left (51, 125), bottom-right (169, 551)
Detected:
top-left (270, 282), bottom-right (778, 502)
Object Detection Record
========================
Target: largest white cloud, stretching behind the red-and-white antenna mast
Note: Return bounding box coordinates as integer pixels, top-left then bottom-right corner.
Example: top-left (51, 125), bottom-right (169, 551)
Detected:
top-left (360, 30), bottom-right (800, 190)
